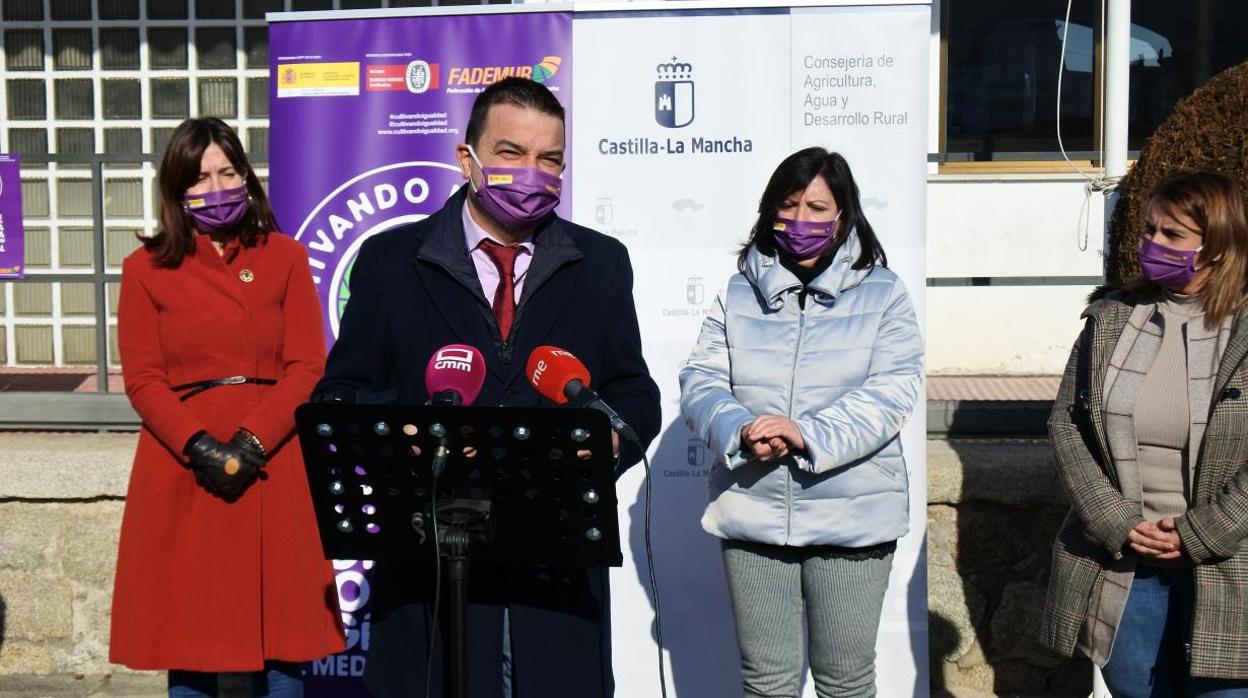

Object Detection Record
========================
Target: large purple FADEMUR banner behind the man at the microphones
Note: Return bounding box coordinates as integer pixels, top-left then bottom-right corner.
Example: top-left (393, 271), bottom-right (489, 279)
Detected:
top-left (270, 12), bottom-right (572, 697)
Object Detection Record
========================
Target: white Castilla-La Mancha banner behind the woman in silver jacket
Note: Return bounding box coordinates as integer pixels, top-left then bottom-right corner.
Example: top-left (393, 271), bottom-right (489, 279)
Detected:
top-left (572, 4), bottom-right (930, 698)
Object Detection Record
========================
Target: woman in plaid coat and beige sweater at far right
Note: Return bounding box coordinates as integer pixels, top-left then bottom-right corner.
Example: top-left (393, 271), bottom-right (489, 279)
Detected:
top-left (1041, 172), bottom-right (1248, 698)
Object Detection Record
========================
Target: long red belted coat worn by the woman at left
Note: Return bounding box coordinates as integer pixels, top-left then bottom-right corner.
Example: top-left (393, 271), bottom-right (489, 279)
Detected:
top-left (110, 233), bottom-right (343, 672)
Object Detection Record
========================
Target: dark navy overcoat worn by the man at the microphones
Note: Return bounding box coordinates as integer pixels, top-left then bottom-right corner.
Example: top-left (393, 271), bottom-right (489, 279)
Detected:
top-left (317, 190), bottom-right (659, 698)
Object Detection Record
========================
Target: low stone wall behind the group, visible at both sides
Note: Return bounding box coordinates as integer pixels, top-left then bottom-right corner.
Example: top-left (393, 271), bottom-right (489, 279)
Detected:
top-left (0, 433), bottom-right (1091, 698)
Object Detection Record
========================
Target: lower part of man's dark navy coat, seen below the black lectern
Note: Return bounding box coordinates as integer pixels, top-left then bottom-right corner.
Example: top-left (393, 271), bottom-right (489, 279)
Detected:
top-left (364, 563), bottom-right (615, 698)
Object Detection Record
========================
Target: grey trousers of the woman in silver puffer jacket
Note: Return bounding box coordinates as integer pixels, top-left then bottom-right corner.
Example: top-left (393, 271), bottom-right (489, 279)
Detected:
top-left (723, 541), bottom-right (894, 698)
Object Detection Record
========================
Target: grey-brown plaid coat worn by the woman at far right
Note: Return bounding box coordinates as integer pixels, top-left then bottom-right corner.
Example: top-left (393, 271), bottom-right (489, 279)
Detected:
top-left (1040, 291), bottom-right (1248, 679)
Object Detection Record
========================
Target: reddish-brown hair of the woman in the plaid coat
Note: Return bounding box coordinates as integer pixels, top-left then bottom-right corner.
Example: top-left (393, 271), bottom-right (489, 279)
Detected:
top-left (1128, 170), bottom-right (1248, 327)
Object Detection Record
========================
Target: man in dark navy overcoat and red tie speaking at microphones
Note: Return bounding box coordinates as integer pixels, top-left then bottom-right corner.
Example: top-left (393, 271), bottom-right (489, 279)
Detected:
top-left (316, 77), bottom-right (659, 698)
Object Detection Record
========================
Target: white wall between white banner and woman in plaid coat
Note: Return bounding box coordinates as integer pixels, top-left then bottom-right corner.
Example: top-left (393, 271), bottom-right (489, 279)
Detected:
top-left (927, 175), bottom-right (1104, 375)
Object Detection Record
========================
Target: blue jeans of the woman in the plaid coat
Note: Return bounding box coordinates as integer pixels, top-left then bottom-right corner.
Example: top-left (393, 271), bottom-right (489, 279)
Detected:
top-left (1101, 566), bottom-right (1248, 698)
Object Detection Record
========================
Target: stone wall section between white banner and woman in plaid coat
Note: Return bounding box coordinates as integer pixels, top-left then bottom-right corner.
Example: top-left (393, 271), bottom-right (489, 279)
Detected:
top-left (927, 440), bottom-right (1092, 698)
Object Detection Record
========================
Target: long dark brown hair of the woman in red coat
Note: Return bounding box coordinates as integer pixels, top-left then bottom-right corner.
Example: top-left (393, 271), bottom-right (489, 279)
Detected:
top-left (141, 116), bottom-right (277, 268)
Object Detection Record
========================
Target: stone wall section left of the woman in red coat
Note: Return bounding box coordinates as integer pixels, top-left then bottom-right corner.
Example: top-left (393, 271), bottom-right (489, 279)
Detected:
top-left (0, 433), bottom-right (135, 686)
